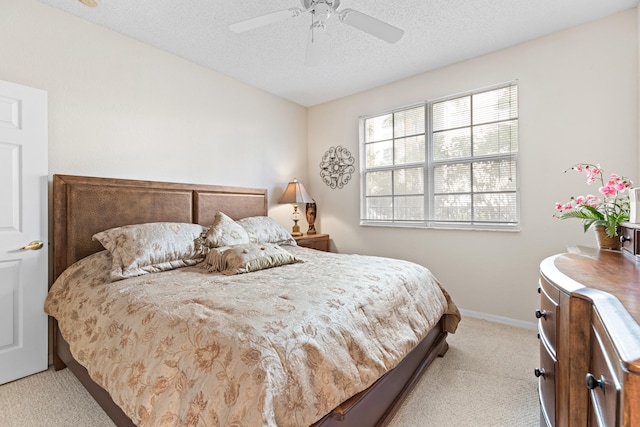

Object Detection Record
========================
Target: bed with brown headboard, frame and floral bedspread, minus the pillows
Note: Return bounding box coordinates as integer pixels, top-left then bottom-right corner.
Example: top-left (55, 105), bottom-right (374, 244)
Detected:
top-left (47, 175), bottom-right (460, 426)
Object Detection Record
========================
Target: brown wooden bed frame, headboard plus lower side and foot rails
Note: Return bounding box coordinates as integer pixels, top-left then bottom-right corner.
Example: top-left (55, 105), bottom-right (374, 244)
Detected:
top-left (53, 175), bottom-right (448, 427)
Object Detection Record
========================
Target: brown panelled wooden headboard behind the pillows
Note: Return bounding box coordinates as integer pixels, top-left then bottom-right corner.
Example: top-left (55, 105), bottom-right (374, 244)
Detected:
top-left (53, 175), bottom-right (268, 280)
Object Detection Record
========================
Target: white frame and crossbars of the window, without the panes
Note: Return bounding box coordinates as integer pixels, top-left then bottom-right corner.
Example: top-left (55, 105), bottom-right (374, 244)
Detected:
top-left (359, 80), bottom-right (521, 231)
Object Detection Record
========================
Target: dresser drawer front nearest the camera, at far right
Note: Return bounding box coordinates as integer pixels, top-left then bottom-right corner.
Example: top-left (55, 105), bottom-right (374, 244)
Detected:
top-left (585, 313), bottom-right (622, 426)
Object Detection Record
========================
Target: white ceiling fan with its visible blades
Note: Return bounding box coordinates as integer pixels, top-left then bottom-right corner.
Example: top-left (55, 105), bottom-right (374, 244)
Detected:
top-left (229, 0), bottom-right (404, 66)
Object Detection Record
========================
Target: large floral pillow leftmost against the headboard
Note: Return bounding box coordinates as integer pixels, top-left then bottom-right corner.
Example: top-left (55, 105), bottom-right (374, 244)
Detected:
top-left (93, 222), bottom-right (206, 281)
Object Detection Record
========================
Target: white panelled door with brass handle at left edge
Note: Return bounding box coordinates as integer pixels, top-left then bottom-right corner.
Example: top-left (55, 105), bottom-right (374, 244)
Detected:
top-left (0, 80), bottom-right (48, 384)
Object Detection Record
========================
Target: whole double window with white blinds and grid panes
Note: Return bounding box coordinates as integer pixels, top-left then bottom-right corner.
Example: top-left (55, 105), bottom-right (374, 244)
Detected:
top-left (360, 82), bottom-right (520, 229)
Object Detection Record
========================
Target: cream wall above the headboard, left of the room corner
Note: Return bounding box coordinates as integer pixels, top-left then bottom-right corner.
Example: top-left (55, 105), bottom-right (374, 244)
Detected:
top-left (0, 0), bottom-right (307, 226)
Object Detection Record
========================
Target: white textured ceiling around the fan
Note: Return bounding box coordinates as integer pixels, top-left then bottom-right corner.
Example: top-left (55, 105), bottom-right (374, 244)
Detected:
top-left (39, 0), bottom-right (638, 106)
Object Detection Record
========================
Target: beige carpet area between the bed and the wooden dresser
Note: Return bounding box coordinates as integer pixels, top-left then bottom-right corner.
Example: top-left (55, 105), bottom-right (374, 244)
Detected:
top-left (389, 317), bottom-right (540, 427)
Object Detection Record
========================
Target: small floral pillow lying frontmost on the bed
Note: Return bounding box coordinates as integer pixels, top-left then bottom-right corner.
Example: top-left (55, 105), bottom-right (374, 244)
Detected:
top-left (205, 243), bottom-right (302, 275)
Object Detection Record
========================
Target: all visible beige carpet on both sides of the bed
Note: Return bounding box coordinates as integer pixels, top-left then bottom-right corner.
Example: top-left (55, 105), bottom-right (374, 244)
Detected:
top-left (0, 317), bottom-right (540, 427)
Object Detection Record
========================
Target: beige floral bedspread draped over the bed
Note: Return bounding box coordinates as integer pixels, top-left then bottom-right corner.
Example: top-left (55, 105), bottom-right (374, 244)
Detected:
top-left (45, 246), bottom-right (459, 427)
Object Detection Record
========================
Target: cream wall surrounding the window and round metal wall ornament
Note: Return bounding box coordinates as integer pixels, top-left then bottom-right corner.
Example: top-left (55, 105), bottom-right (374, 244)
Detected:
top-left (305, 10), bottom-right (639, 322)
